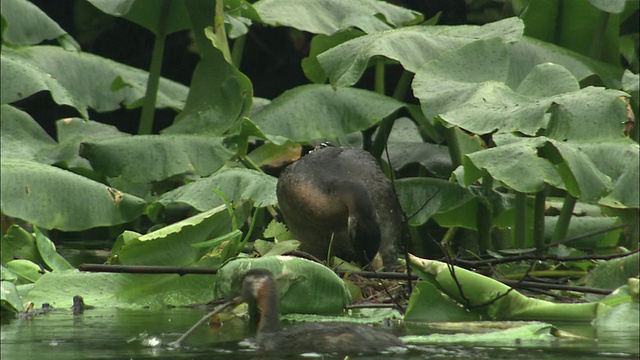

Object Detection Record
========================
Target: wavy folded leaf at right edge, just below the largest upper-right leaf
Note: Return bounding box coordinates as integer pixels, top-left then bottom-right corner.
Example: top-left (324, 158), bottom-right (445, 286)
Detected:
top-left (454, 135), bottom-right (640, 208)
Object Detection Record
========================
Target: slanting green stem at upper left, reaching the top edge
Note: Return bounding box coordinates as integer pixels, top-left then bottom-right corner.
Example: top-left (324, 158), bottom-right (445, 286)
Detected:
top-left (138, 0), bottom-right (171, 135)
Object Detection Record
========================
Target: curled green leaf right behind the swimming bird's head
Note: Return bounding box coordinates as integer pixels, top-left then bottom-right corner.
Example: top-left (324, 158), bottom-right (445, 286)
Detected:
top-left (215, 256), bottom-right (351, 314)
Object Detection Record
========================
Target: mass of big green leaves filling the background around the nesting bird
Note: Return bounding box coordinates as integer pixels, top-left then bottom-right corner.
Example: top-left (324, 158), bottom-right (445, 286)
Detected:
top-left (0, 0), bottom-right (640, 318)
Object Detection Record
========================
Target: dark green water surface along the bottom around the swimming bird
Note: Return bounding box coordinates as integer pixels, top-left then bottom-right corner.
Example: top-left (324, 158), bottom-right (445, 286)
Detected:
top-left (0, 309), bottom-right (639, 360)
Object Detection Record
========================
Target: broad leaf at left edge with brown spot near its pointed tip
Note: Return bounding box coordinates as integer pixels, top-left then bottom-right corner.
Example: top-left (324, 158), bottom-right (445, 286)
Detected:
top-left (0, 159), bottom-right (146, 231)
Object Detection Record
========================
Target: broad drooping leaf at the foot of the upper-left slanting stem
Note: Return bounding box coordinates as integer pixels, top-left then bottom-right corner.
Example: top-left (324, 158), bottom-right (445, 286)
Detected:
top-left (80, 135), bottom-right (233, 183)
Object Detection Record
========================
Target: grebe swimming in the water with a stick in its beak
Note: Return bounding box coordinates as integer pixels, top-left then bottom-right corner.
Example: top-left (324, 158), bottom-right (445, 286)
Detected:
top-left (242, 269), bottom-right (405, 354)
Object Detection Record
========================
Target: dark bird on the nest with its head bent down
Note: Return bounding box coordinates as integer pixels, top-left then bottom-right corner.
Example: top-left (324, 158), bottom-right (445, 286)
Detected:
top-left (277, 146), bottom-right (402, 266)
